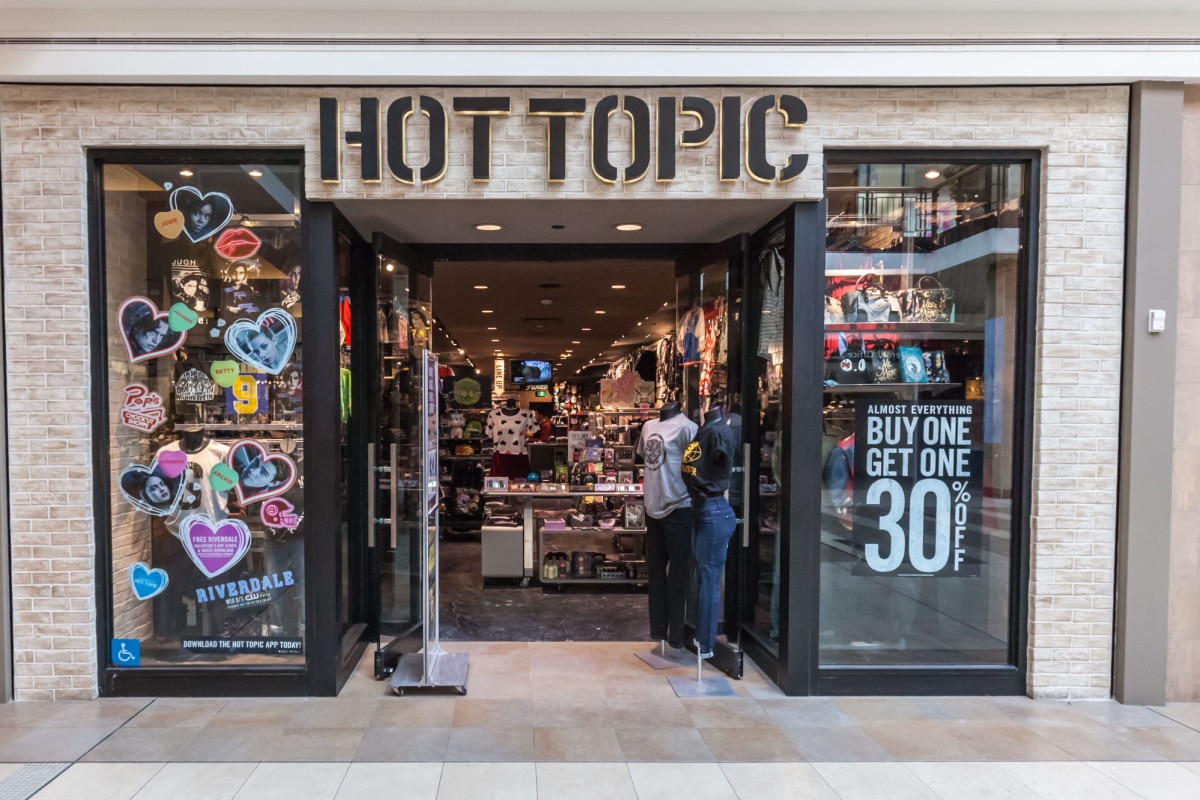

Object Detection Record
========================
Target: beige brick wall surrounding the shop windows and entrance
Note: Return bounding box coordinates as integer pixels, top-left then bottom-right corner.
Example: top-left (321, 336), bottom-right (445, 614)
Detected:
top-left (0, 86), bottom-right (1128, 699)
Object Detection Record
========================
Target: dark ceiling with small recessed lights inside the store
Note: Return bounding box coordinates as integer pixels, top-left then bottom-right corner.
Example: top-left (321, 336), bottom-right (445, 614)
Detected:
top-left (433, 259), bottom-right (676, 379)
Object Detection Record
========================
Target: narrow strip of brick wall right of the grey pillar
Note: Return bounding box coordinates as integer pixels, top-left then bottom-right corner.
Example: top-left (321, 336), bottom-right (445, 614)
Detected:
top-left (1166, 86), bottom-right (1200, 702)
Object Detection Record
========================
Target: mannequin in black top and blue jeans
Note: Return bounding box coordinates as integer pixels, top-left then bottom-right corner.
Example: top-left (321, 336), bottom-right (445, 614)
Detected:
top-left (679, 405), bottom-right (737, 658)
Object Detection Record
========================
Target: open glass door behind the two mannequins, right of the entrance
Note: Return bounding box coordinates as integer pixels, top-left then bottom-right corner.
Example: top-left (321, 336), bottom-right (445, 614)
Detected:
top-left (676, 235), bottom-right (749, 678)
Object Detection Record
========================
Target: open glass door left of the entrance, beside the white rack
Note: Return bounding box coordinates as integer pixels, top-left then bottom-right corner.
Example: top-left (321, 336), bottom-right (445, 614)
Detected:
top-left (360, 234), bottom-right (436, 679)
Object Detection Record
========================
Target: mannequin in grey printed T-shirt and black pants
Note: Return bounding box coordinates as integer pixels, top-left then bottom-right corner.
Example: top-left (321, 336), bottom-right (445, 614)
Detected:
top-left (637, 401), bottom-right (696, 656)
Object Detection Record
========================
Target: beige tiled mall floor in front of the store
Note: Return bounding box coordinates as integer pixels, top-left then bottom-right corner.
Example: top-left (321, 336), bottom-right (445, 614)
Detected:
top-left (0, 643), bottom-right (1200, 800)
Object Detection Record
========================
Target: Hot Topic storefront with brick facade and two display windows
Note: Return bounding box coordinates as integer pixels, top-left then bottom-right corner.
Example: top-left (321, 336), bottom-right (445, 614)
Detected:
top-left (0, 85), bottom-right (1129, 698)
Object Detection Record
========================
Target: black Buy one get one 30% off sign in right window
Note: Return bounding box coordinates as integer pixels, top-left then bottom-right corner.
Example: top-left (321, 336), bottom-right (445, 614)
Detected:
top-left (853, 402), bottom-right (983, 577)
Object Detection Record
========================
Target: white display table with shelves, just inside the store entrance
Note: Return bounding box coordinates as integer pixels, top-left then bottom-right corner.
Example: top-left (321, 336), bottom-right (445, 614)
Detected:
top-left (481, 489), bottom-right (646, 585)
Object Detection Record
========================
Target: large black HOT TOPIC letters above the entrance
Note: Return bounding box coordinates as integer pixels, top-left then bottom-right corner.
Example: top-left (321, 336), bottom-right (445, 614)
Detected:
top-left (320, 95), bottom-right (809, 185)
